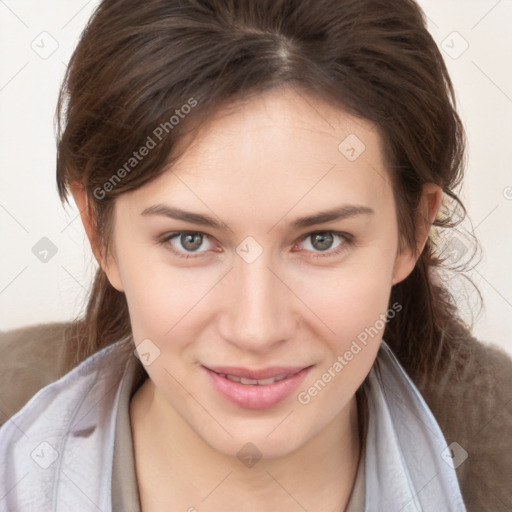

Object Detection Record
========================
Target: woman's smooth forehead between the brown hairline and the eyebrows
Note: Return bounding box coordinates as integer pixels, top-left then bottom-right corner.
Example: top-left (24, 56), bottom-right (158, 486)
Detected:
top-left (120, 87), bottom-right (391, 222)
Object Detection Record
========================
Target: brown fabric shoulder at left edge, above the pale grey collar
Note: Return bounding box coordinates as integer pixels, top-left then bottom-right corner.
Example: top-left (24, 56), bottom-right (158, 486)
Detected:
top-left (0, 322), bottom-right (72, 425)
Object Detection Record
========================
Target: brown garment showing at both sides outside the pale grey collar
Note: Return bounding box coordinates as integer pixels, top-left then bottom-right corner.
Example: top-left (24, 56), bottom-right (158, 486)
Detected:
top-left (0, 323), bottom-right (512, 512)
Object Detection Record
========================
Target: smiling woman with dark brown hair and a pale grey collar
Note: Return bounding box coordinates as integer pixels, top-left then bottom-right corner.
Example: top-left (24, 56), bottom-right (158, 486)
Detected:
top-left (0, 0), bottom-right (512, 512)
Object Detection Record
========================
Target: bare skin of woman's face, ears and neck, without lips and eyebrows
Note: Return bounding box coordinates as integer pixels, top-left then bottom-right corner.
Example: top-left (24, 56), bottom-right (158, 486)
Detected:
top-left (72, 88), bottom-right (442, 512)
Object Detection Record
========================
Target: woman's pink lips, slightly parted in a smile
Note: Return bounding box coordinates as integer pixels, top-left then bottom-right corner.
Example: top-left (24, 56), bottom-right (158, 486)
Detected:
top-left (202, 365), bottom-right (314, 409)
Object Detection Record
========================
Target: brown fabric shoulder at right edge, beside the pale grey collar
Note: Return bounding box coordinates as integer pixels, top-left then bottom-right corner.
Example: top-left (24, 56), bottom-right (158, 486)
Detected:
top-left (418, 328), bottom-right (512, 512)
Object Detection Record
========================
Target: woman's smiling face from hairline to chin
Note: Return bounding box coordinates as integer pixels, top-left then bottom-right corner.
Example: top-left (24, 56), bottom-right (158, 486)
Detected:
top-left (102, 89), bottom-right (414, 458)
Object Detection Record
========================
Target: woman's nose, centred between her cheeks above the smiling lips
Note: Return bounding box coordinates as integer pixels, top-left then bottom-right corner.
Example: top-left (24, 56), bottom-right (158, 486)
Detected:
top-left (219, 251), bottom-right (298, 352)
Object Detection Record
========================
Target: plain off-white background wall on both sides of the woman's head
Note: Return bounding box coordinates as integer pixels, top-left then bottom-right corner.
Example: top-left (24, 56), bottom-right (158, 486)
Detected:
top-left (0, 0), bottom-right (512, 354)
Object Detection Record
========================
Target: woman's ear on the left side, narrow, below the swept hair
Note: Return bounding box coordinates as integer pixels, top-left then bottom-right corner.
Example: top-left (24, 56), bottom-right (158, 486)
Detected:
top-left (69, 181), bottom-right (124, 292)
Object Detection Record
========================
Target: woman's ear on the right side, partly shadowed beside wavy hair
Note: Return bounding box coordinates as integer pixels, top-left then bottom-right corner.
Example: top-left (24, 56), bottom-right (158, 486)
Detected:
top-left (392, 183), bottom-right (443, 285)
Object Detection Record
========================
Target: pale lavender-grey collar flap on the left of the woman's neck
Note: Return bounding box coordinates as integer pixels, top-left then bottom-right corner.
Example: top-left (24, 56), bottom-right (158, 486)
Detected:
top-left (0, 341), bottom-right (131, 510)
